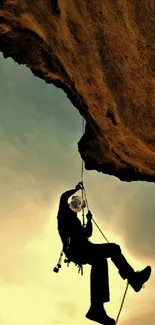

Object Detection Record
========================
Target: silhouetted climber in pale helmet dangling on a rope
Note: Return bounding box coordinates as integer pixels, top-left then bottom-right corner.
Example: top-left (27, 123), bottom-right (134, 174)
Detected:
top-left (57, 182), bottom-right (151, 325)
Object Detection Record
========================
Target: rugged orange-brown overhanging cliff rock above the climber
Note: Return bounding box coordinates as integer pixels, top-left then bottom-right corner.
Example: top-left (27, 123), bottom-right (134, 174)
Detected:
top-left (0, 0), bottom-right (155, 181)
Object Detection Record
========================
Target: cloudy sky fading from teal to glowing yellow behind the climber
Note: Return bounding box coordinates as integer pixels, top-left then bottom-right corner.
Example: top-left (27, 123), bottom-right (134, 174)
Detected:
top-left (0, 54), bottom-right (155, 325)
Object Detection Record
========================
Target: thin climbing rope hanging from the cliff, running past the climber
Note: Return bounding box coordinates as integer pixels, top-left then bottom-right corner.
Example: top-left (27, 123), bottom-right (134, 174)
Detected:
top-left (81, 117), bottom-right (129, 325)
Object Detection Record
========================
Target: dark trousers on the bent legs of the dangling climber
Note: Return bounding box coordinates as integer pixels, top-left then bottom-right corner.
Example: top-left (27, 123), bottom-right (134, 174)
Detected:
top-left (87, 242), bottom-right (134, 306)
